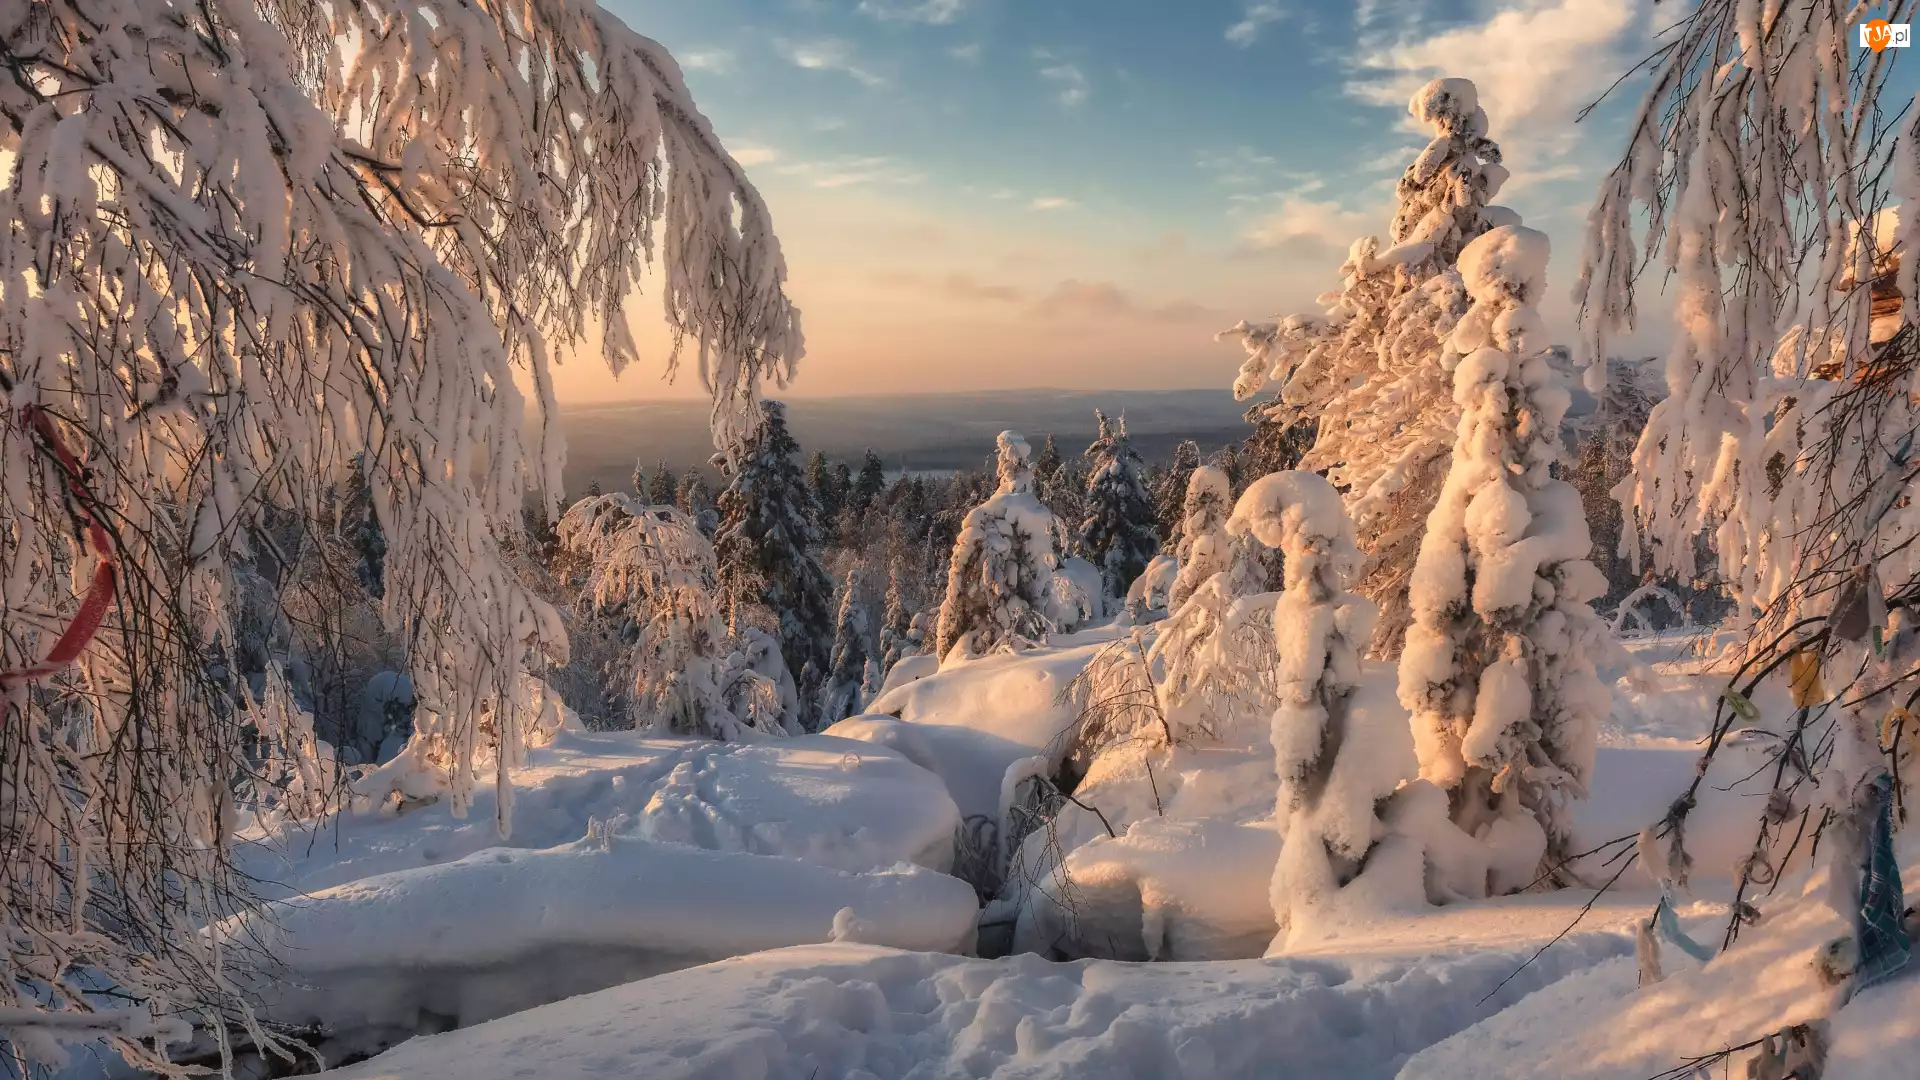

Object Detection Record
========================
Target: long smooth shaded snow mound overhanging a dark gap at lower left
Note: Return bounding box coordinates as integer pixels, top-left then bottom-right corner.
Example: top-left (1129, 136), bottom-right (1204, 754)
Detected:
top-left (240, 834), bottom-right (977, 1038)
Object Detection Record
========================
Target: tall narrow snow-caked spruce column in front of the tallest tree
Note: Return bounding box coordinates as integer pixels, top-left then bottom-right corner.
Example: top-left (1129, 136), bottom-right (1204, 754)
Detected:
top-left (1390, 225), bottom-right (1609, 892)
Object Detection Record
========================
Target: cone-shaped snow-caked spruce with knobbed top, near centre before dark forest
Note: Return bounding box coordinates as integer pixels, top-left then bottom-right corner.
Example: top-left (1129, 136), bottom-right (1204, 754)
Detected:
top-left (935, 430), bottom-right (1054, 663)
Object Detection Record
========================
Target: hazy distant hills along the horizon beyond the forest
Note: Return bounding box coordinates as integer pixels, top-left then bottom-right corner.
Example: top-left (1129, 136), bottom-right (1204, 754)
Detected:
top-left (561, 390), bottom-right (1250, 492)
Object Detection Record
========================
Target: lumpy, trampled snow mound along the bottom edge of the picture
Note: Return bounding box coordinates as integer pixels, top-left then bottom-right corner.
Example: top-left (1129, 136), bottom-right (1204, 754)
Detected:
top-left (318, 936), bottom-right (1630, 1080)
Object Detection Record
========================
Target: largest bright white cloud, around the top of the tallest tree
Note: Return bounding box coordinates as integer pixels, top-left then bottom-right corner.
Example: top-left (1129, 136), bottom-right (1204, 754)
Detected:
top-left (1346, 0), bottom-right (1647, 160)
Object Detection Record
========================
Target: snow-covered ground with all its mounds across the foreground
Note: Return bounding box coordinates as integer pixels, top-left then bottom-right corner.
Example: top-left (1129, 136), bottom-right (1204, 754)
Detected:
top-left (165, 630), bottom-right (1920, 1080)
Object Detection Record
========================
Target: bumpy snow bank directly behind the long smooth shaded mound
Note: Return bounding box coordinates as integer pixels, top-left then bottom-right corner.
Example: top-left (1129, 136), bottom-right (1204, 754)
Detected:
top-left (238, 730), bottom-right (960, 897)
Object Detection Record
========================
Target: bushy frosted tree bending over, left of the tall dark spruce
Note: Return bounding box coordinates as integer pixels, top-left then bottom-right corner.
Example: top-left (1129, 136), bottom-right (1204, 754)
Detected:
top-left (559, 494), bottom-right (797, 740)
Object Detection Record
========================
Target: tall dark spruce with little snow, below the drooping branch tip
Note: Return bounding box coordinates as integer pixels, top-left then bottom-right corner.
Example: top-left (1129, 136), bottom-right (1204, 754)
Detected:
top-left (714, 402), bottom-right (833, 730)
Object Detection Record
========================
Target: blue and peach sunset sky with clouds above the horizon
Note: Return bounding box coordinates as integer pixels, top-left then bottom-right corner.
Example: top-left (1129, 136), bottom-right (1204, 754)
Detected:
top-left (561, 0), bottom-right (1653, 400)
